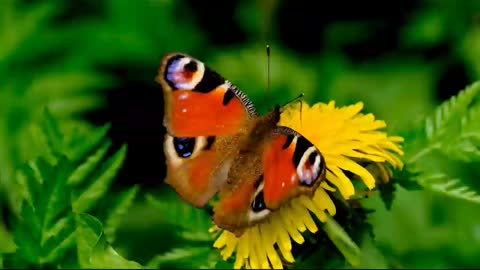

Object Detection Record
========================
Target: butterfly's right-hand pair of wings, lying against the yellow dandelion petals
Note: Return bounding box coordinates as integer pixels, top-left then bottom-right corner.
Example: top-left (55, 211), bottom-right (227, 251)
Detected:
top-left (214, 123), bottom-right (326, 235)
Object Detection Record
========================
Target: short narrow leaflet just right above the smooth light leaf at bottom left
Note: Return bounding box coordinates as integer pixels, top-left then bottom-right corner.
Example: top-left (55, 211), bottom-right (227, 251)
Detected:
top-left (104, 186), bottom-right (140, 243)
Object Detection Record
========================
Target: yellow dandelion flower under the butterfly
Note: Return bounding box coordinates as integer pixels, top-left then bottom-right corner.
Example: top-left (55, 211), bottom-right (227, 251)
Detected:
top-left (211, 101), bottom-right (403, 269)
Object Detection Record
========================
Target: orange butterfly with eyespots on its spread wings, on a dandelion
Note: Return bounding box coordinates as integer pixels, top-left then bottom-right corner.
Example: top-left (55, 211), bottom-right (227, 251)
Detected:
top-left (155, 53), bottom-right (326, 236)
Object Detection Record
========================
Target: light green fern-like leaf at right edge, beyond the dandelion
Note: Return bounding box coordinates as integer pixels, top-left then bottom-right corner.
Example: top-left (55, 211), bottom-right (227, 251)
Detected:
top-left (403, 81), bottom-right (480, 203)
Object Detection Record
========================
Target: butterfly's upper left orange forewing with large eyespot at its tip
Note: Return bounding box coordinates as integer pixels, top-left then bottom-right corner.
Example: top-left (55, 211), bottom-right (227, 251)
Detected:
top-left (157, 54), bottom-right (256, 137)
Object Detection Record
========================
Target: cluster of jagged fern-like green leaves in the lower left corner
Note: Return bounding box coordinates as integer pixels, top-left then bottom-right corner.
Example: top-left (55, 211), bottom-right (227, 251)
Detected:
top-left (6, 110), bottom-right (135, 268)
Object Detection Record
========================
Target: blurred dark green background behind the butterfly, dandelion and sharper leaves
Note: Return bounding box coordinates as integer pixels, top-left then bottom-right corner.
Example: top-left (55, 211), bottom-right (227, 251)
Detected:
top-left (0, 0), bottom-right (480, 268)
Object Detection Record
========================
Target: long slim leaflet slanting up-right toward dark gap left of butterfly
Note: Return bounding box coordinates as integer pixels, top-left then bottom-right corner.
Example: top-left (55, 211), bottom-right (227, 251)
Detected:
top-left (72, 145), bottom-right (127, 213)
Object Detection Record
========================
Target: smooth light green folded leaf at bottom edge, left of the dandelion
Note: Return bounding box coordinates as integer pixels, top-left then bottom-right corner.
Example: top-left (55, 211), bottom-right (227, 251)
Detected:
top-left (75, 213), bottom-right (142, 269)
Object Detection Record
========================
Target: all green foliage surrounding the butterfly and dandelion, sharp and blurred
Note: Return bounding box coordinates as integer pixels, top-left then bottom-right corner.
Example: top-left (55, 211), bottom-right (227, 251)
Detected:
top-left (0, 0), bottom-right (480, 268)
